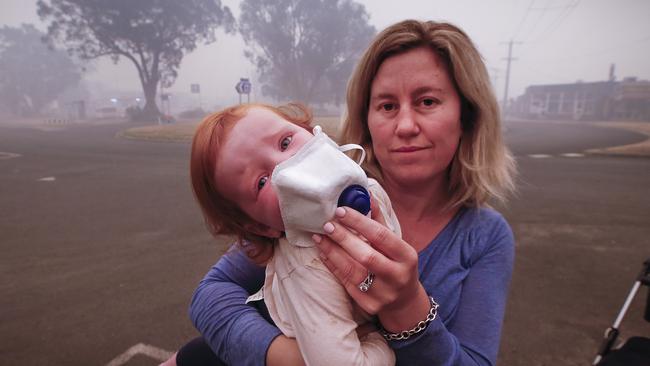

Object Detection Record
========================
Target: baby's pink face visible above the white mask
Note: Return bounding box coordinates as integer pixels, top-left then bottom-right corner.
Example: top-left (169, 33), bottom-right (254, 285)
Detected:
top-left (215, 108), bottom-right (313, 231)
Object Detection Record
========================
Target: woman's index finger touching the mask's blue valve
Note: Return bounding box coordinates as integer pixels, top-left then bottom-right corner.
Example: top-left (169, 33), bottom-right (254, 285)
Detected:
top-left (332, 207), bottom-right (417, 264)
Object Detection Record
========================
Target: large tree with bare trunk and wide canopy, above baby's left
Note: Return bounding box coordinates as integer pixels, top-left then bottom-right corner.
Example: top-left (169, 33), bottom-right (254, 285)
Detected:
top-left (37, 0), bottom-right (234, 117)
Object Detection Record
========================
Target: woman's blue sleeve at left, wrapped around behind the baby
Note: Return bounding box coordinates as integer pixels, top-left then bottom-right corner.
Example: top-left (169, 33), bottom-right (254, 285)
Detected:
top-left (190, 249), bottom-right (281, 365)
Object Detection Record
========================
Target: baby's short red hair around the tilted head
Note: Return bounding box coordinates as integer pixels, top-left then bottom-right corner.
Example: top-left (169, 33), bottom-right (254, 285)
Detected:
top-left (190, 103), bottom-right (312, 263)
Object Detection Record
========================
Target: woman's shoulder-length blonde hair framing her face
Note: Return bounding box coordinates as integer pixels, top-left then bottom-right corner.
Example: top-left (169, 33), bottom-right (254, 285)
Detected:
top-left (339, 20), bottom-right (516, 206)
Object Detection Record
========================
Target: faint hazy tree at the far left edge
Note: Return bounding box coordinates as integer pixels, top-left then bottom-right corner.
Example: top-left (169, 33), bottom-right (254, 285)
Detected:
top-left (0, 24), bottom-right (81, 117)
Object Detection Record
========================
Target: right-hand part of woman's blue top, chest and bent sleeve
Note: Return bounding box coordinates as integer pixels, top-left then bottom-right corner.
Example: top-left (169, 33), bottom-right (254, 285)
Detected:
top-left (391, 209), bottom-right (514, 365)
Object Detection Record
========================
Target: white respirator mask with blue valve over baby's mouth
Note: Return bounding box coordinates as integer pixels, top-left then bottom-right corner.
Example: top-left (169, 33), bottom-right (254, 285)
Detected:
top-left (271, 126), bottom-right (370, 247)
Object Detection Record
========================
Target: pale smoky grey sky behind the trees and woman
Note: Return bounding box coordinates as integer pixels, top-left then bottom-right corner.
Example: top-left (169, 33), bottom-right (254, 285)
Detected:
top-left (0, 0), bottom-right (650, 108)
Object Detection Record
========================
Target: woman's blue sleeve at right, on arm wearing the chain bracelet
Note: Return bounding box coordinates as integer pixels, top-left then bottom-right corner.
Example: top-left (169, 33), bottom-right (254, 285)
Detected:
top-left (390, 215), bottom-right (514, 365)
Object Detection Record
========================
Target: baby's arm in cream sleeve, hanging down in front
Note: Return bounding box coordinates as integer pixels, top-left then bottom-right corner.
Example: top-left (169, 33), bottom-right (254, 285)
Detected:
top-left (275, 256), bottom-right (395, 365)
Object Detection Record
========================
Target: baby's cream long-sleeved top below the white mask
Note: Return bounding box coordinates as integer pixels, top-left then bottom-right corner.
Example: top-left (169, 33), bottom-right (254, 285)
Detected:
top-left (264, 241), bottom-right (395, 366)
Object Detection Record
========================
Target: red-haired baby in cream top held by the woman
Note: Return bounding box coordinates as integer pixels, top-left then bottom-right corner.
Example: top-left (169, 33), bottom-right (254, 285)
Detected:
top-left (190, 104), bottom-right (400, 365)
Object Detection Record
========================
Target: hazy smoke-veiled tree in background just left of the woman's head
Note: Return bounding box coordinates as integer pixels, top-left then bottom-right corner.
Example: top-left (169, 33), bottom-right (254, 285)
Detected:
top-left (239, 0), bottom-right (375, 104)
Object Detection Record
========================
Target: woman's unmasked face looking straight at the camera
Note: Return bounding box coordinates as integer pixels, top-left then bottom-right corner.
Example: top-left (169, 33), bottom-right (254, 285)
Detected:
top-left (368, 47), bottom-right (461, 188)
